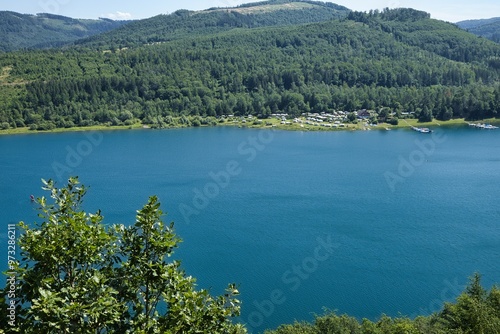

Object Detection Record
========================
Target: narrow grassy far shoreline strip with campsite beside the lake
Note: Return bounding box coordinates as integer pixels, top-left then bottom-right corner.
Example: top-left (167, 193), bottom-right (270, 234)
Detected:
top-left (0, 118), bottom-right (500, 136)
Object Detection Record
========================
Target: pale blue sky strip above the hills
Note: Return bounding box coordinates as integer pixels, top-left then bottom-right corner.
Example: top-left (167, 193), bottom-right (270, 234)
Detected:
top-left (0, 0), bottom-right (500, 22)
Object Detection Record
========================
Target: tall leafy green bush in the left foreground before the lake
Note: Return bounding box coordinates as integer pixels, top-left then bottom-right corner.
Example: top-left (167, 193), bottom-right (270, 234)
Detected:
top-left (2, 178), bottom-right (245, 333)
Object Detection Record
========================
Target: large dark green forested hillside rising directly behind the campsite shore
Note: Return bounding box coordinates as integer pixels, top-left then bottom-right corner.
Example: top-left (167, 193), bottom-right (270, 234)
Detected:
top-left (0, 9), bottom-right (500, 129)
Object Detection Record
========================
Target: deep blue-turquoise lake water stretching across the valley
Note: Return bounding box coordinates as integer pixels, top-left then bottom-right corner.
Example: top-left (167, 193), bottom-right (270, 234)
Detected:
top-left (0, 127), bottom-right (500, 333)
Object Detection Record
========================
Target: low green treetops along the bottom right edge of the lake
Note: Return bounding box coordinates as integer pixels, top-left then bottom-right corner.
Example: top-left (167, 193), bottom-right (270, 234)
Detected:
top-left (265, 274), bottom-right (500, 334)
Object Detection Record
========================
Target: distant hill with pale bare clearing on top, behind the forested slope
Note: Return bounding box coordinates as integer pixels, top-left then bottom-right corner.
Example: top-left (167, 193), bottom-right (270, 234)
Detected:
top-left (77, 0), bottom-right (350, 49)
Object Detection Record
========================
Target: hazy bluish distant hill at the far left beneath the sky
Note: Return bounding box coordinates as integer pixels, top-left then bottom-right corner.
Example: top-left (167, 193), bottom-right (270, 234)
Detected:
top-left (0, 11), bottom-right (131, 51)
